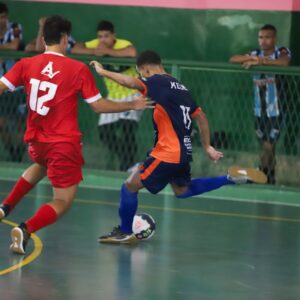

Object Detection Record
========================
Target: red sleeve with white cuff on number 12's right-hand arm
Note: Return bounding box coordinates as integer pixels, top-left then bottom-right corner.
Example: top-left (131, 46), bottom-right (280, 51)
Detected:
top-left (80, 65), bottom-right (101, 103)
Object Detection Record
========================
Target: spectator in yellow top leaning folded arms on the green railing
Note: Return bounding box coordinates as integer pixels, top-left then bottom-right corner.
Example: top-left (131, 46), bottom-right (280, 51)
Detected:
top-left (72, 21), bottom-right (141, 171)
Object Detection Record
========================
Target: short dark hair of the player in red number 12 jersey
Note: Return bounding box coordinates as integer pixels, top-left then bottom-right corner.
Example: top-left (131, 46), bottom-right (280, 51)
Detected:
top-left (43, 16), bottom-right (72, 46)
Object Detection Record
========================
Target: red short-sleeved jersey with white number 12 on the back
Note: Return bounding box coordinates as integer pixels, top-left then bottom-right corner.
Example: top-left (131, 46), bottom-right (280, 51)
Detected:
top-left (0, 52), bottom-right (101, 143)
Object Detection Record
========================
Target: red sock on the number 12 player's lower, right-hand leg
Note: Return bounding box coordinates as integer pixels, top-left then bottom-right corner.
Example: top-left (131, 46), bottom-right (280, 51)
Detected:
top-left (25, 204), bottom-right (58, 233)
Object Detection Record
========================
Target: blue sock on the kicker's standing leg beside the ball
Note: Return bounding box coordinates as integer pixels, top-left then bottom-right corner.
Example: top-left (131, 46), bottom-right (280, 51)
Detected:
top-left (119, 183), bottom-right (138, 233)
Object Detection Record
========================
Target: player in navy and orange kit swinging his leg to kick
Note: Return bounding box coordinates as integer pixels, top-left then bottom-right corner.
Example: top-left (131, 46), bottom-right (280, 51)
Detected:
top-left (91, 50), bottom-right (266, 243)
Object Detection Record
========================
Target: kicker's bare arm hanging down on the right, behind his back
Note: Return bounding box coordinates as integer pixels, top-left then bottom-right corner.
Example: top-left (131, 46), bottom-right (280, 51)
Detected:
top-left (193, 111), bottom-right (223, 161)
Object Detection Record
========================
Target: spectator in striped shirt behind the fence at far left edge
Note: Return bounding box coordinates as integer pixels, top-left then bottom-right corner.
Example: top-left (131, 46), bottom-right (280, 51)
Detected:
top-left (0, 3), bottom-right (25, 161)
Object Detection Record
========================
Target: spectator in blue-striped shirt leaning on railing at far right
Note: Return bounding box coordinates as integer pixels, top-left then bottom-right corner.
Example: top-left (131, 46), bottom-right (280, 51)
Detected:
top-left (230, 24), bottom-right (291, 184)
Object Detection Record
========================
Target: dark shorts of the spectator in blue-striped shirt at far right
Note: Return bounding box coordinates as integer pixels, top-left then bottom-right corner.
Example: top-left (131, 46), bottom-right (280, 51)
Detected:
top-left (255, 117), bottom-right (282, 144)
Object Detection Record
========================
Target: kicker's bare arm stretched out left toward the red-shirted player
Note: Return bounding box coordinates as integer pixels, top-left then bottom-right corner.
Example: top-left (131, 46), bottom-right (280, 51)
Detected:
top-left (90, 60), bottom-right (145, 92)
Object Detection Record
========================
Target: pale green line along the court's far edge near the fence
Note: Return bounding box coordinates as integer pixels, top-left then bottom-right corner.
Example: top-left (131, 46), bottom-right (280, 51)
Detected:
top-left (0, 177), bottom-right (300, 207)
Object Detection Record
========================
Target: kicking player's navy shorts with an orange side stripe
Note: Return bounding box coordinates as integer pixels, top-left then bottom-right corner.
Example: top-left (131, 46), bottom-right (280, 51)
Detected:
top-left (140, 157), bottom-right (191, 194)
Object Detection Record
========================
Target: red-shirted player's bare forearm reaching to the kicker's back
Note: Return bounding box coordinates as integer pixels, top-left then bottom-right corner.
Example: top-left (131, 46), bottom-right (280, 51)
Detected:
top-left (90, 96), bottom-right (153, 113)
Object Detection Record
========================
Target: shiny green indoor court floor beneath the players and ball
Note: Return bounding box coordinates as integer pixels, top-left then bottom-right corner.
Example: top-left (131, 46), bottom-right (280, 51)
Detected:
top-left (0, 171), bottom-right (300, 300)
